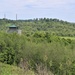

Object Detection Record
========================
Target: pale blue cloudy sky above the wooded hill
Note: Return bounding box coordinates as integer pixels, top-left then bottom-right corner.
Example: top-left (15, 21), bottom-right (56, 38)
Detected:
top-left (0, 0), bottom-right (75, 22)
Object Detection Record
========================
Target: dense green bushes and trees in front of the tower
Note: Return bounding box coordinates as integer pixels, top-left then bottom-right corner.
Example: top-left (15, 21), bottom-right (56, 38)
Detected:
top-left (0, 32), bottom-right (75, 75)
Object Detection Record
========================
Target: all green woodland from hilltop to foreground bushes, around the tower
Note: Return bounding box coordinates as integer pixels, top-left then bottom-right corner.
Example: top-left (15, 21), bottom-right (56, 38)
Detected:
top-left (0, 18), bottom-right (75, 75)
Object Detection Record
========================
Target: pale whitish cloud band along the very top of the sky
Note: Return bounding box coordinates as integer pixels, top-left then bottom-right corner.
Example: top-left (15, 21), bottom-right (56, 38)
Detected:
top-left (0, 0), bottom-right (75, 9)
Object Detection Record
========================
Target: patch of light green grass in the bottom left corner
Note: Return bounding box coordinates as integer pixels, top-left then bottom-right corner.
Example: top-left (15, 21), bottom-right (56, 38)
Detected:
top-left (0, 62), bottom-right (34, 75)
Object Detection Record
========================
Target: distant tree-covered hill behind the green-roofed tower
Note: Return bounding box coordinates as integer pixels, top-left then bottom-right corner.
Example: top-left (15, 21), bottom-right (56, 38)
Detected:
top-left (0, 18), bottom-right (75, 36)
